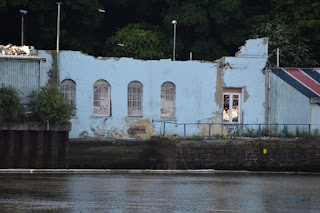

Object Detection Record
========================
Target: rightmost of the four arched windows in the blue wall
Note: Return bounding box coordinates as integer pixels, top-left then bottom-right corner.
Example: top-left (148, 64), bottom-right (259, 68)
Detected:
top-left (161, 82), bottom-right (176, 118)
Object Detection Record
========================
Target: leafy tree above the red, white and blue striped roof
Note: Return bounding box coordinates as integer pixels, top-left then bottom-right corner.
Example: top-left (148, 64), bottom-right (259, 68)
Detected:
top-left (254, 0), bottom-right (320, 67)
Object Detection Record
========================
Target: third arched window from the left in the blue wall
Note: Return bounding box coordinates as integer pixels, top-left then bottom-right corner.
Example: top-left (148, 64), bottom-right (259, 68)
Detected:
top-left (128, 81), bottom-right (143, 117)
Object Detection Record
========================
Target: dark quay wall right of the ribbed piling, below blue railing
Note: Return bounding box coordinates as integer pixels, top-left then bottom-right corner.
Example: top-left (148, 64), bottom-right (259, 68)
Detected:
top-left (69, 139), bottom-right (320, 172)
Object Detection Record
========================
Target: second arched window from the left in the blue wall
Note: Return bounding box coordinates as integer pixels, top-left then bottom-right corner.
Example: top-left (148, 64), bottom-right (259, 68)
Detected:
top-left (92, 79), bottom-right (111, 117)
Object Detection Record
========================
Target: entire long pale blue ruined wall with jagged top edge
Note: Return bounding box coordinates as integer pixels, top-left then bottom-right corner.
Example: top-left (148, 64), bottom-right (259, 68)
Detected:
top-left (35, 39), bottom-right (268, 139)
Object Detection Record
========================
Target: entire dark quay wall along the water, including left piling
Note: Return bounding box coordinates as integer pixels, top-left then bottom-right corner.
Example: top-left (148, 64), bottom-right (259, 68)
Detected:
top-left (0, 130), bottom-right (320, 172)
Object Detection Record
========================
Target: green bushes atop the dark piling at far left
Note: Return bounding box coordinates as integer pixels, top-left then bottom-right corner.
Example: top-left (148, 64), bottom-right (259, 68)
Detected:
top-left (0, 85), bottom-right (76, 126)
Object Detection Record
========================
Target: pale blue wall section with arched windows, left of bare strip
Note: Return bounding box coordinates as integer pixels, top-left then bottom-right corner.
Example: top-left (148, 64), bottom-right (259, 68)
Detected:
top-left (60, 51), bottom-right (219, 139)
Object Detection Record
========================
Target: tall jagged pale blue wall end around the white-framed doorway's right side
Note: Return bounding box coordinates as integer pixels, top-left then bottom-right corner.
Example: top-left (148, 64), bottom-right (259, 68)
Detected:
top-left (224, 38), bottom-right (268, 124)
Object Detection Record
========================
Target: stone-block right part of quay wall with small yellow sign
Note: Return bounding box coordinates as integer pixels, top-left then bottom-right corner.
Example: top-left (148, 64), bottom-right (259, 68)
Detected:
top-left (176, 140), bottom-right (320, 172)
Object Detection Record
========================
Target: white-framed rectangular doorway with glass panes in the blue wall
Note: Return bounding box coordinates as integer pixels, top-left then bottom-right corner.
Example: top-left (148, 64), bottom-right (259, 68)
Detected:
top-left (223, 88), bottom-right (241, 123)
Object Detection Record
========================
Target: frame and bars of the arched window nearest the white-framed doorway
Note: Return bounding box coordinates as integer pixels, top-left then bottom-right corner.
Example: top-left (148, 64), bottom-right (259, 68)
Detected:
top-left (160, 81), bottom-right (176, 119)
